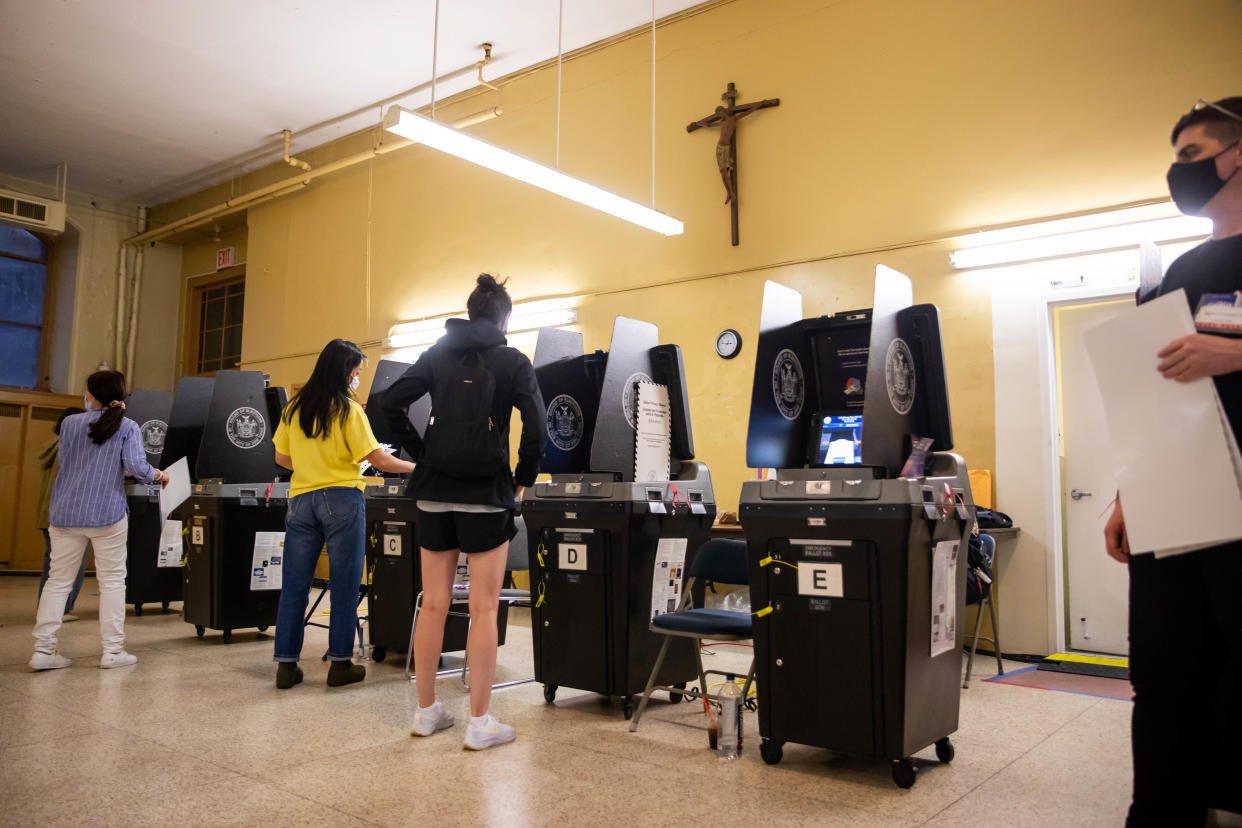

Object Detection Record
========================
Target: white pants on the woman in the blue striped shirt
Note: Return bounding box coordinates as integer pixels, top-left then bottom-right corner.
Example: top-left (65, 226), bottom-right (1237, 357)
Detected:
top-left (35, 515), bottom-right (129, 653)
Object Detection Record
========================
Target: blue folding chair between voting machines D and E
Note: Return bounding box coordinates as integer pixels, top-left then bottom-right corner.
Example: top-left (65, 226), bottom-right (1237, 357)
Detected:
top-left (630, 538), bottom-right (755, 732)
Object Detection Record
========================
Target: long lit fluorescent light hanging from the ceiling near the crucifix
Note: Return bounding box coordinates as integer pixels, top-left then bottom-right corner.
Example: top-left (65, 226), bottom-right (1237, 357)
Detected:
top-left (384, 107), bottom-right (686, 236)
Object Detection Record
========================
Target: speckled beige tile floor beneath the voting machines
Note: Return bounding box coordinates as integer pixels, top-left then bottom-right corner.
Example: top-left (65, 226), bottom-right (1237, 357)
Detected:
top-left (0, 577), bottom-right (1130, 828)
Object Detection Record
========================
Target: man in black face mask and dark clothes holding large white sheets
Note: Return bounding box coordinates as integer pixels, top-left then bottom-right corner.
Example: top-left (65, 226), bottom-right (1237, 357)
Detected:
top-left (1104, 97), bottom-right (1242, 826)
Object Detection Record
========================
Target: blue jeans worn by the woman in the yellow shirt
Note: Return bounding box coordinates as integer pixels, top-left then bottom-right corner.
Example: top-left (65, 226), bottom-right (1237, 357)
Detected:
top-left (274, 487), bottom-right (366, 662)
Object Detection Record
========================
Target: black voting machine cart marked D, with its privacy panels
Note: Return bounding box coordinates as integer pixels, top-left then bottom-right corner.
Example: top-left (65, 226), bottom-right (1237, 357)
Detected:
top-left (522, 317), bottom-right (715, 719)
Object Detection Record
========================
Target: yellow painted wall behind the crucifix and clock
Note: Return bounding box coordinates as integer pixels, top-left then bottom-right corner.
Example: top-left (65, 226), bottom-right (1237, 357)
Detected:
top-left (155, 0), bottom-right (1242, 648)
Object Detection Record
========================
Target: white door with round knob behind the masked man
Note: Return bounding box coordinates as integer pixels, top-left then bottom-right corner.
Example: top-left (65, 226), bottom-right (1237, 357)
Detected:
top-left (1052, 297), bottom-right (1134, 655)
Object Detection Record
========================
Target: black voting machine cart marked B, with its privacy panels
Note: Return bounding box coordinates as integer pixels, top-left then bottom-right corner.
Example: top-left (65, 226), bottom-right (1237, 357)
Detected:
top-left (170, 371), bottom-right (289, 644)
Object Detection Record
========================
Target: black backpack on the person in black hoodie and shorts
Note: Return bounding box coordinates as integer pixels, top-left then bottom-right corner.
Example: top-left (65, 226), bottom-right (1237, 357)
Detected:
top-left (420, 350), bottom-right (508, 480)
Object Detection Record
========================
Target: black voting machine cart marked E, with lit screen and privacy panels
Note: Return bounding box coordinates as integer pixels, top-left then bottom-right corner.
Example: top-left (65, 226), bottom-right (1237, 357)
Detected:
top-left (740, 267), bottom-right (974, 787)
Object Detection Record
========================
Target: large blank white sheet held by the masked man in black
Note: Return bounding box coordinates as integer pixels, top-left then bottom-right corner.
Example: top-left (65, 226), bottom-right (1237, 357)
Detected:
top-left (1083, 290), bottom-right (1242, 557)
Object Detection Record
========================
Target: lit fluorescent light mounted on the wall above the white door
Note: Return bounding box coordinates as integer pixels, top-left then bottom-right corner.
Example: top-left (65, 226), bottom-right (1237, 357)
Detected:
top-left (949, 216), bottom-right (1212, 271)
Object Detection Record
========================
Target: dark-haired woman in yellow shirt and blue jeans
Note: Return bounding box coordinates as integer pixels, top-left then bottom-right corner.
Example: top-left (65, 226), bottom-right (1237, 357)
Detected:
top-left (272, 339), bottom-right (414, 690)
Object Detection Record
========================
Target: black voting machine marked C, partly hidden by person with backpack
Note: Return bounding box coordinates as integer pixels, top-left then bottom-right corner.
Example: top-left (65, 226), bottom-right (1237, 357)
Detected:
top-left (365, 360), bottom-right (491, 662)
